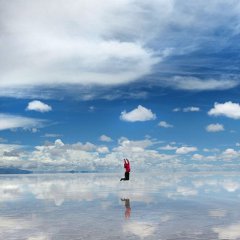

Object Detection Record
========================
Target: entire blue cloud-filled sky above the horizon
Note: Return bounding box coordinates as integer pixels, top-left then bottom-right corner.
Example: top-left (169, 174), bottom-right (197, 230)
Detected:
top-left (0, 0), bottom-right (240, 171)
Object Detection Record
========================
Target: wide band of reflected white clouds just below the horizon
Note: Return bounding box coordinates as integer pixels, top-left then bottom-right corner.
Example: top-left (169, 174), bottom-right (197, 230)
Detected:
top-left (0, 173), bottom-right (240, 206)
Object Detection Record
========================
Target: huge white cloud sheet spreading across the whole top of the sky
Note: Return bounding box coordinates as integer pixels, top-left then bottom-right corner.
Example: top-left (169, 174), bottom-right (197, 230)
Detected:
top-left (0, 0), bottom-right (239, 98)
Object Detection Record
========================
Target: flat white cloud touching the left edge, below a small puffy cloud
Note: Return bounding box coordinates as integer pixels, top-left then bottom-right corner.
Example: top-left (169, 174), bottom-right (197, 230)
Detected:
top-left (0, 113), bottom-right (44, 131)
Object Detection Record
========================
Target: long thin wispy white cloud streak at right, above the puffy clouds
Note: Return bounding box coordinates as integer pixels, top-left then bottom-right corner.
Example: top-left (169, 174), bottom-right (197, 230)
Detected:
top-left (169, 76), bottom-right (239, 91)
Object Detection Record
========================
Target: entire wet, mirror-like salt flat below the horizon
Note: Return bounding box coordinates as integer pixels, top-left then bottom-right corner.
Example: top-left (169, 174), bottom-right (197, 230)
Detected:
top-left (0, 173), bottom-right (240, 240)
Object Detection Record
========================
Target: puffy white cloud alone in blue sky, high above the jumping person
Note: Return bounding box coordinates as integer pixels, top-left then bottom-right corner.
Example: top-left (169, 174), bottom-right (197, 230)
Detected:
top-left (120, 105), bottom-right (156, 122)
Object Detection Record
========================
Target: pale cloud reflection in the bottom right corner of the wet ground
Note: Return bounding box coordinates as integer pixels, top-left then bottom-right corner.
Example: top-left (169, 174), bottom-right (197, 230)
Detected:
top-left (213, 223), bottom-right (240, 240)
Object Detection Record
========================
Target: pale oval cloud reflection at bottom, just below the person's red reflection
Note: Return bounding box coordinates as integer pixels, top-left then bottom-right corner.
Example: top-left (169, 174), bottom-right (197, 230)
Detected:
top-left (123, 221), bottom-right (155, 239)
